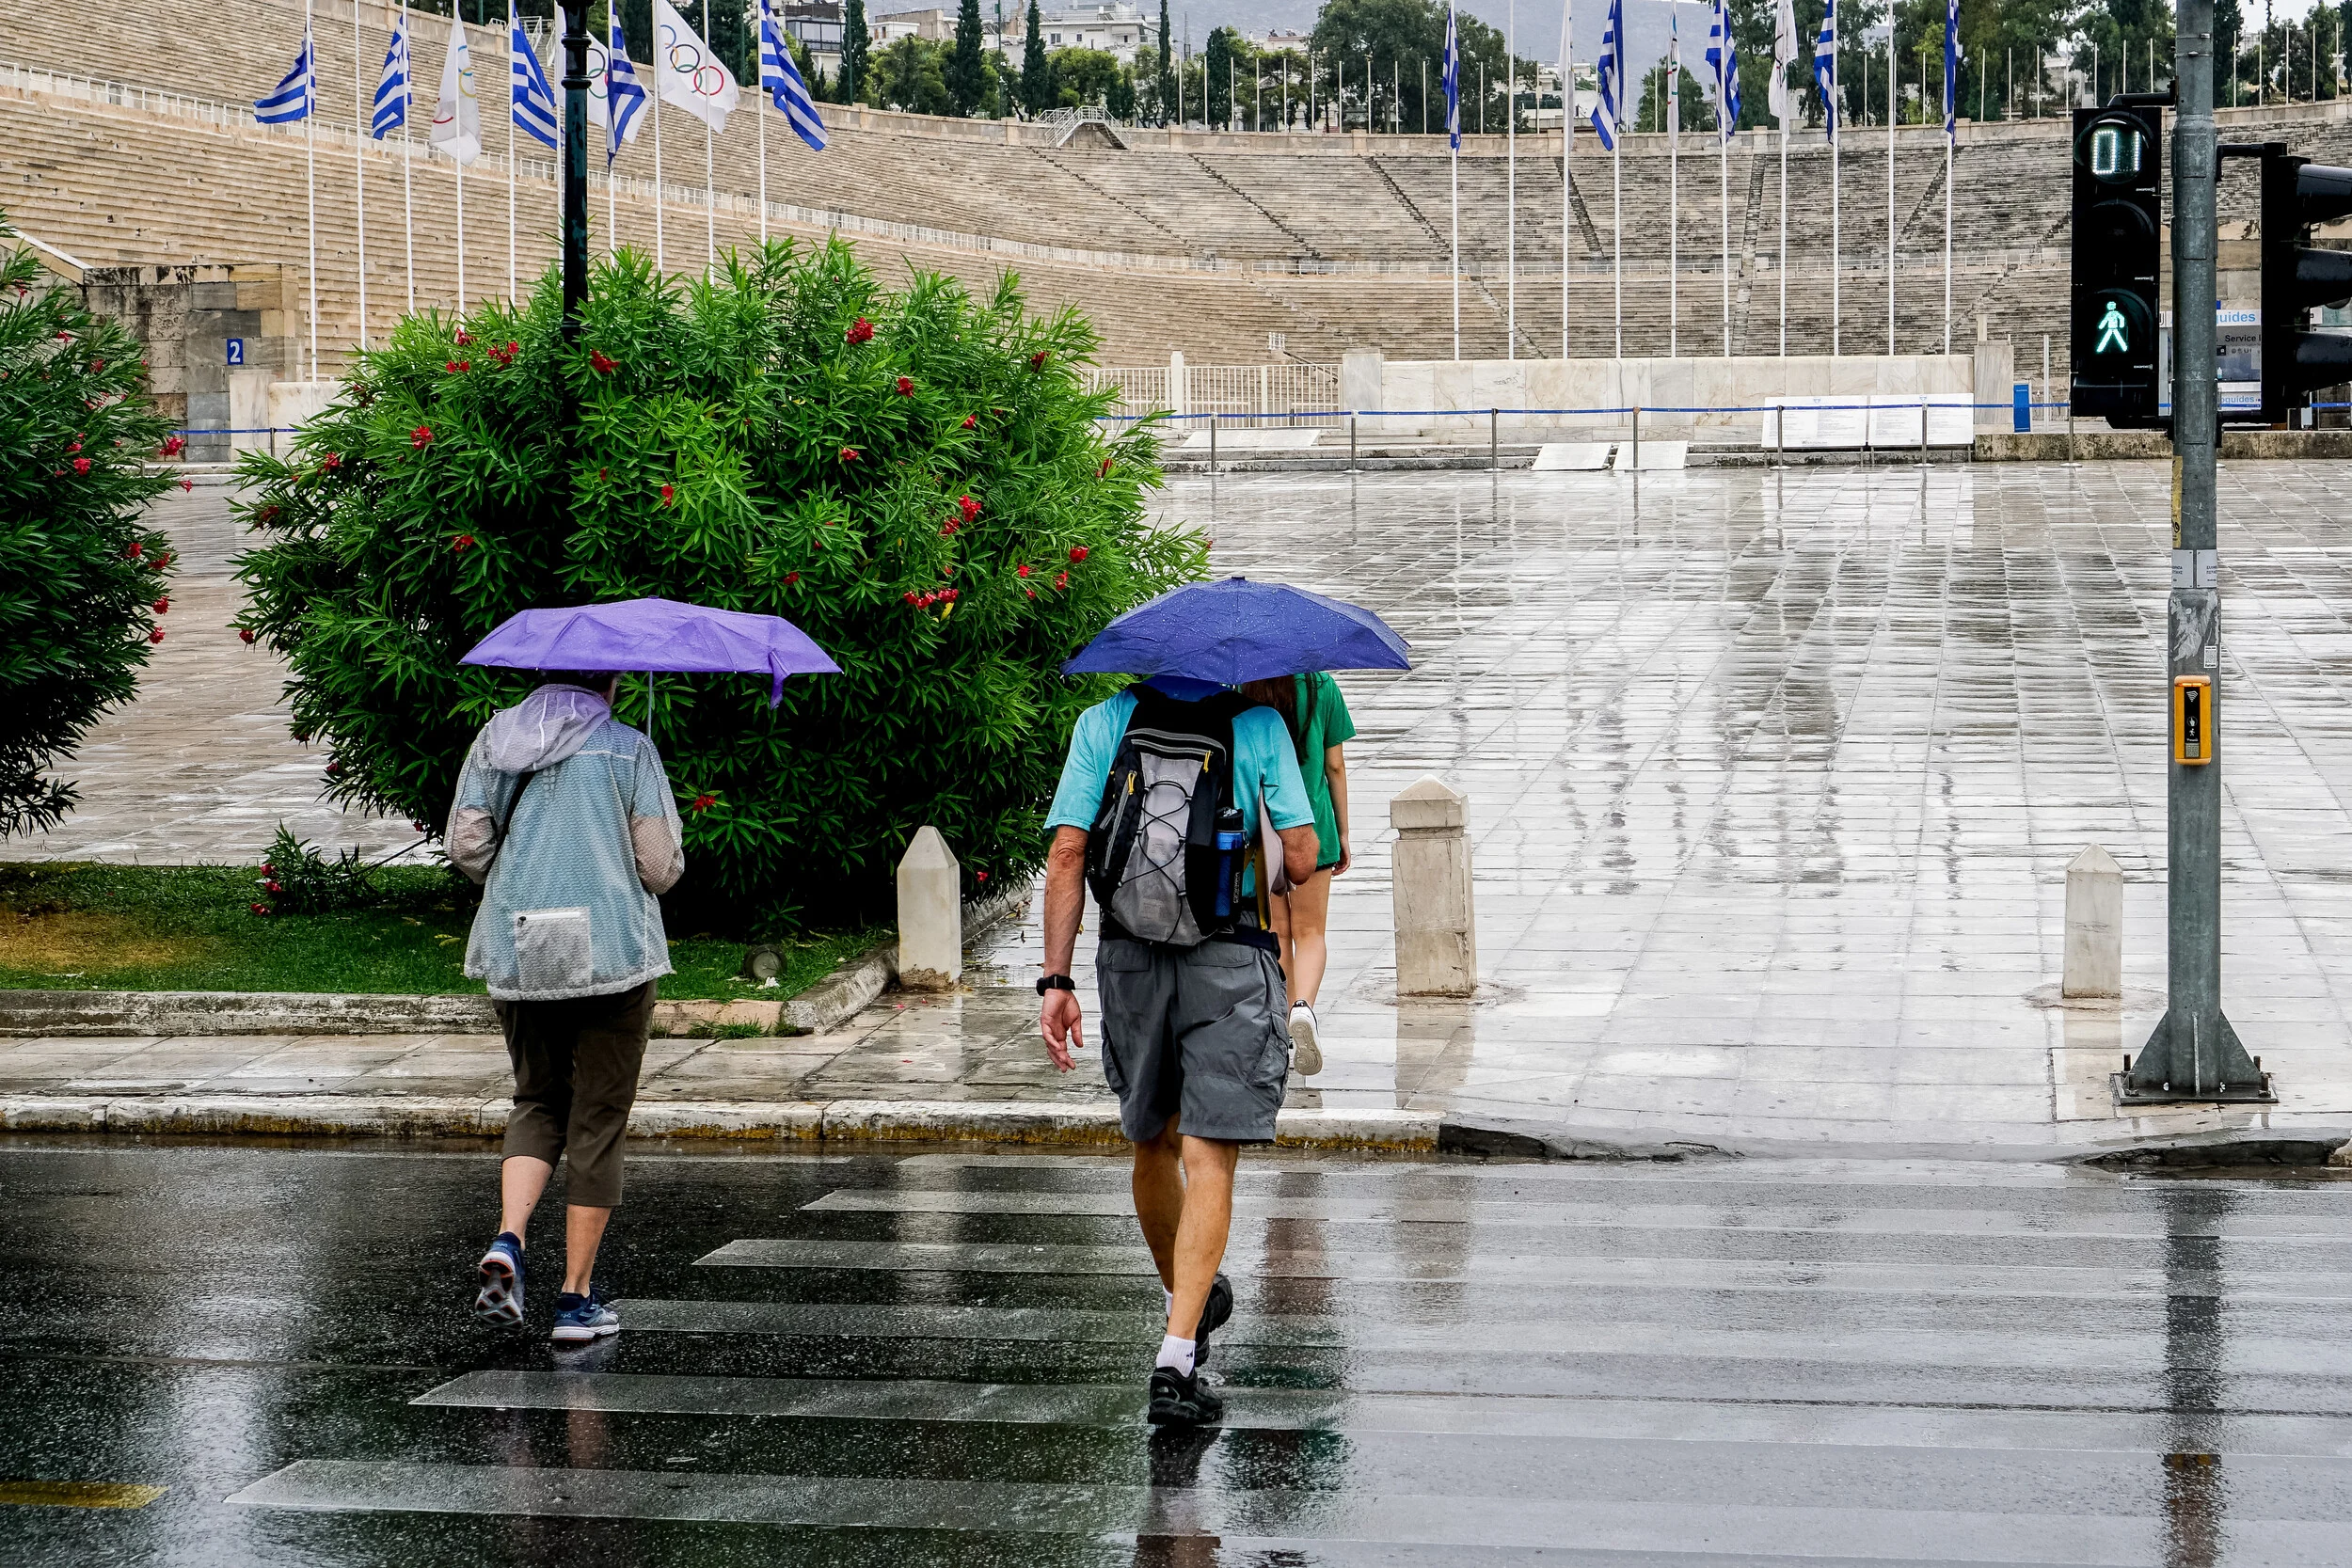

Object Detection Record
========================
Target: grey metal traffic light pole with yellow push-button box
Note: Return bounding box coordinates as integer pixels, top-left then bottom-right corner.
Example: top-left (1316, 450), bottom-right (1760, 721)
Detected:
top-left (2115, 0), bottom-right (2277, 1102)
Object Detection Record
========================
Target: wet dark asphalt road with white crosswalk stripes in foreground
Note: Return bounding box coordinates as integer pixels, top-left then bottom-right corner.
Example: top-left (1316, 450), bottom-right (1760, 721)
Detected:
top-left (0, 1140), bottom-right (2352, 1568)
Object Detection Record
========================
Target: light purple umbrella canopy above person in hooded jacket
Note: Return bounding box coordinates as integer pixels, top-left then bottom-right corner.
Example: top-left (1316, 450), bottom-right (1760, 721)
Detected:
top-left (459, 599), bottom-right (842, 707)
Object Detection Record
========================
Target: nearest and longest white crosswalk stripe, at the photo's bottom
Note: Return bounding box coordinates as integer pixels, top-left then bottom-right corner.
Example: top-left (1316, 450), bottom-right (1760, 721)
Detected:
top-left (230, 1460), bottom-right (2341, 1568)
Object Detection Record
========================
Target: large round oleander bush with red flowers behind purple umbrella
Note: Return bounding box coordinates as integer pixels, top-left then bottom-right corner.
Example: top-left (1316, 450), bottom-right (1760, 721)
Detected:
top-left (240, 242), bottom-right (1207, 928)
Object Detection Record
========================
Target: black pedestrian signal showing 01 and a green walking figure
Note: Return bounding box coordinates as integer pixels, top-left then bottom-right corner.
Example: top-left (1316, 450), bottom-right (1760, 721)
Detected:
top-left (2073, 103), bottom-right (2164, 428)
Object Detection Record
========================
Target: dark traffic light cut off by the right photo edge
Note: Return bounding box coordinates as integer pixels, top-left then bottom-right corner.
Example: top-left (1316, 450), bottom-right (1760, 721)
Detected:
top-left (2263, 141), bottom-right (2352, 425)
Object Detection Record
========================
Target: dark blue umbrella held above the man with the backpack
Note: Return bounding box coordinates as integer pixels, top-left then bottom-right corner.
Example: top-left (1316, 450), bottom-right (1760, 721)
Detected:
top-left (1061, 576), bottom-right (1414, 687)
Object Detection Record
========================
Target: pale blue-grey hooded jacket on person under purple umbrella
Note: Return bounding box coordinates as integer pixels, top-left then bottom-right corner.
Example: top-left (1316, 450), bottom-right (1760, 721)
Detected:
top-left (447, 687), bottom-right (687, 1002)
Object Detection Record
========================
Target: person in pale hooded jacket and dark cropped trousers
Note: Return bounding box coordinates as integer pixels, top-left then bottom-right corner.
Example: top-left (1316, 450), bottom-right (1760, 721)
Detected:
top-left (447, 670), bottom-right (687, 1345)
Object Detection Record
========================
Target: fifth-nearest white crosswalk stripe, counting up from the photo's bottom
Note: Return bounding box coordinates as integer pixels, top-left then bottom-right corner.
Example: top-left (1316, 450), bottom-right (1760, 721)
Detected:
top-left (803, 1187), bottom-right (2352, 1251)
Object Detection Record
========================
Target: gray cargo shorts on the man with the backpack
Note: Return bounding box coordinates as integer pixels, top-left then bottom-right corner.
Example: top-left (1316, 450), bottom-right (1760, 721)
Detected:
top-left (1094, 936), bottom-right (1292, 1143)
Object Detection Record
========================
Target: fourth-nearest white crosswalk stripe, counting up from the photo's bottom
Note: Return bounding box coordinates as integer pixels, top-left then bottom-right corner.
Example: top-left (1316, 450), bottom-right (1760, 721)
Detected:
top-left (696, 1237), bottom-right (2352, 1303)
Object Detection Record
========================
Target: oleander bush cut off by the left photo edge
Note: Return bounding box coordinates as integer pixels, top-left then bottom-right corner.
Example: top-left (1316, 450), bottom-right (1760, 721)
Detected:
top-left (0, 214), bottom-right (179, 837)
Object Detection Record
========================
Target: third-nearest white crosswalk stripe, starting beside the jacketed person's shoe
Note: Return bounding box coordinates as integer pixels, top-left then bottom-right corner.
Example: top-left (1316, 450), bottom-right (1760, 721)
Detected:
top-left (619, 1298), bottom-right (2352, 1378)
